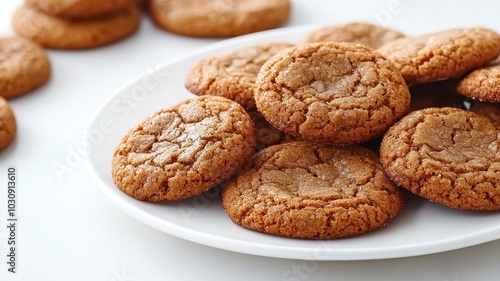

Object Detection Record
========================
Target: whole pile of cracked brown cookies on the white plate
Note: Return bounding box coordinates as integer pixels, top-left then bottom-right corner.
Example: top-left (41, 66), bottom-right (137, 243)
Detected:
top-left (112, 23), bottom-right (500, 239)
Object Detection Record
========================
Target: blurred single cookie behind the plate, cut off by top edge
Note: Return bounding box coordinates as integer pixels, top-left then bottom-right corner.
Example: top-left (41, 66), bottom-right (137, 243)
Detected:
top-left (150, 0), bottom-right (291, 37)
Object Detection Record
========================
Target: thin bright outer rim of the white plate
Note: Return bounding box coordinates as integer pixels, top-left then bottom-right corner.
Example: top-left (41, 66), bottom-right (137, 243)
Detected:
top-left (83, 24), bottom-right (500, 261)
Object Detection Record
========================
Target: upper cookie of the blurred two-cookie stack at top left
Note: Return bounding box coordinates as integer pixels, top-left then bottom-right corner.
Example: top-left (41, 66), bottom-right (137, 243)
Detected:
top-left (26, 0), bottom-right (139, 18)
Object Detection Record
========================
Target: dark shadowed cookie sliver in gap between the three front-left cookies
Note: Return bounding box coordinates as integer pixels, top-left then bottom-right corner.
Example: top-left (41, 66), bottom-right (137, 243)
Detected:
top-left (248, 111), bottom-right (298, 151)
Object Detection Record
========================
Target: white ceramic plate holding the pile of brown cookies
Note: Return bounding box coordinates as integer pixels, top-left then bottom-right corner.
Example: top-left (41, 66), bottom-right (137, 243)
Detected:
top-left (86, 27), bottom-right (500, 260)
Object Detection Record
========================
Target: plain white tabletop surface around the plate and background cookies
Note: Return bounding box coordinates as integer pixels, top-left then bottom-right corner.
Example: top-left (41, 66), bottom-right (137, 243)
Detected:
top-left (0, 0), bottom-right (500, 281)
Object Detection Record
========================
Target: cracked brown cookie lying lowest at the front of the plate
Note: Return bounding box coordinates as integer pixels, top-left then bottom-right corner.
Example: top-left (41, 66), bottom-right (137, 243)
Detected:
top-left (222, 142), bottom-right (403, 239)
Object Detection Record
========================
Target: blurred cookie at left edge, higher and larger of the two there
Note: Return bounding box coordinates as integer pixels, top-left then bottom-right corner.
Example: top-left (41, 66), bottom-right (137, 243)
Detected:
top-left (0, 37), bottom-right (51, 99)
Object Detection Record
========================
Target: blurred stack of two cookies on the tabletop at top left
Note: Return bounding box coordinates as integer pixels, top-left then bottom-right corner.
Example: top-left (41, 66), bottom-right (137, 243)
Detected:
top-left (13, 0), bottom-right (140, 50)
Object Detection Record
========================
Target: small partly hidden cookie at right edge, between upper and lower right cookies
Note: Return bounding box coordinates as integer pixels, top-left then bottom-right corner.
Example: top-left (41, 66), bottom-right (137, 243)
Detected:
top-left (457, 58), bottom-right (500, 102)
